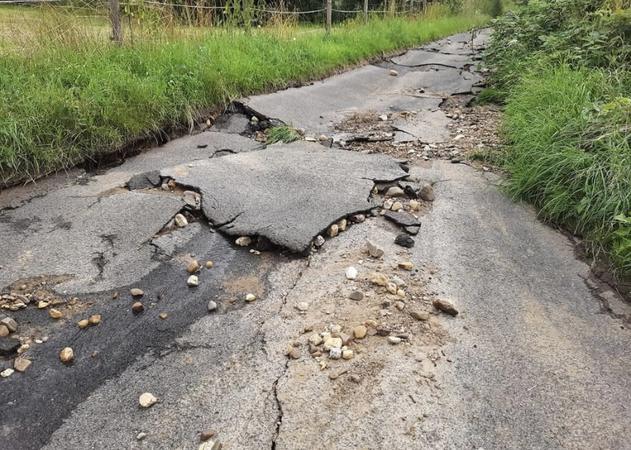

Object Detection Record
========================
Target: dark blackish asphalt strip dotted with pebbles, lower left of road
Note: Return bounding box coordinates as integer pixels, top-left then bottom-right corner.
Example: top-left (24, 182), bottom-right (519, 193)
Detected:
top-left (0, 226), bottom-right (284, 450)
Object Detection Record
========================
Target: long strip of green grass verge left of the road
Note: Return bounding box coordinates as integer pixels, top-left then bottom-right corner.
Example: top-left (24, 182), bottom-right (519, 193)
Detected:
top-left (0, 12), bottom-right (488, 185)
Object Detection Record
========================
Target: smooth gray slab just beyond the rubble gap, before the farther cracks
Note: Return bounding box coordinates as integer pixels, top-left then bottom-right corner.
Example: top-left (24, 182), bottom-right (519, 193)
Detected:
top-left (244, 66), bottom-right (440, 133)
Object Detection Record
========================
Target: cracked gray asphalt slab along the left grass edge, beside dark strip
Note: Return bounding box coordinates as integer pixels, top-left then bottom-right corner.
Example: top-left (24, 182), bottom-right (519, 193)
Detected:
top-left (0, 132), bottom-right (261, 293)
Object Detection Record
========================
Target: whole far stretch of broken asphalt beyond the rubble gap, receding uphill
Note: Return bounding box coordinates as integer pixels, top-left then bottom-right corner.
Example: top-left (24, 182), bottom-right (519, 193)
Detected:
top-left (246, 33), bottom-right (486, 143)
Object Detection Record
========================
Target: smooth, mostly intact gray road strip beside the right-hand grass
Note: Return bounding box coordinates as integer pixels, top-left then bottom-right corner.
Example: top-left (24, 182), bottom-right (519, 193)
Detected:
top-left (412, 162), bottom-right (631, 449)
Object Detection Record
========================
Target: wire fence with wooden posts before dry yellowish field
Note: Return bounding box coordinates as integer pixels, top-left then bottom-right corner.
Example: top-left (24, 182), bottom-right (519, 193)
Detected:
top-left (0, 0), bottom-right (428, 42)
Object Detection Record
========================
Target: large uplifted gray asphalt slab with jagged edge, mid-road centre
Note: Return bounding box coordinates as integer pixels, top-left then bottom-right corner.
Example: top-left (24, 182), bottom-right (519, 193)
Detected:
top-left (162, 142), bottom-right (406, 252)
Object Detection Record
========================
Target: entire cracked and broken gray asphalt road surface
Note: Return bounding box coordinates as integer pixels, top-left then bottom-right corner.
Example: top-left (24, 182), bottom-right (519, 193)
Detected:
top-left (0, 32), bottom-right (631, 449)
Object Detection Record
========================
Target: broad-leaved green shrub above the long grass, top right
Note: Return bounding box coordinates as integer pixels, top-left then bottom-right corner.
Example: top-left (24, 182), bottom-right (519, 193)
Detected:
top-left (486, 0), bottom-right (631, 95)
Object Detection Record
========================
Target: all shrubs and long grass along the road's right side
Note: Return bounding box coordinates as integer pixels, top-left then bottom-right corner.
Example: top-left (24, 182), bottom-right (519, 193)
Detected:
top-left (481, 0), bottom-right (631, 277)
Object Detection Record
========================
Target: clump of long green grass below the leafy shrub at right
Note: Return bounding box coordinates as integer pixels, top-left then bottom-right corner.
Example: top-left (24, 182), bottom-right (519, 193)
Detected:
top-left (504, 66), bottom-right (631, 275)
